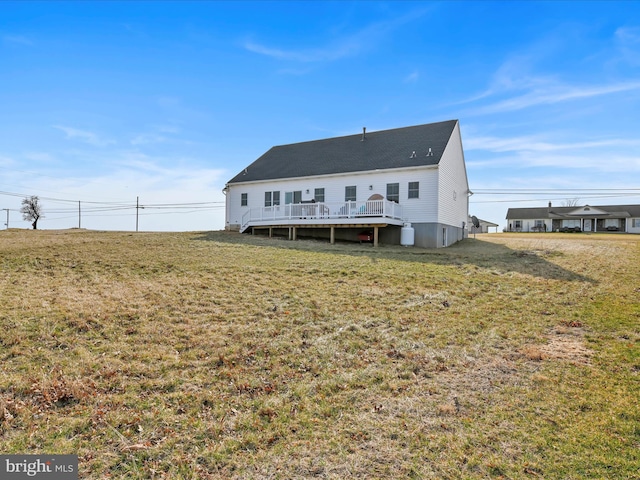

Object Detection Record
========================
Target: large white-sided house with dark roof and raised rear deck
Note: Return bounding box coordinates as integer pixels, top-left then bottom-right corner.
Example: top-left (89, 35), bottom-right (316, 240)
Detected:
top-left (224, 120), bottom-right (471, 247)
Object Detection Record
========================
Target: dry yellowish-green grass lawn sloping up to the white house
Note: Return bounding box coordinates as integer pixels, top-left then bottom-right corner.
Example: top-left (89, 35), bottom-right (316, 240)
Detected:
top-left (0, 230), bottom-right (640, 479)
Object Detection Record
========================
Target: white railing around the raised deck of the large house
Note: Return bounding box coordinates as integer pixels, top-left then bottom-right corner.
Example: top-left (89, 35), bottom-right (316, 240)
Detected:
top-left (242, 200), bottom-right (402, 230)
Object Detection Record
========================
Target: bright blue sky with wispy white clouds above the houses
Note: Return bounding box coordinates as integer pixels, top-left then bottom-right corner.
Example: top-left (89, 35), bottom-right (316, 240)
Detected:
top-left (0, 1), bottom-right (640, 230)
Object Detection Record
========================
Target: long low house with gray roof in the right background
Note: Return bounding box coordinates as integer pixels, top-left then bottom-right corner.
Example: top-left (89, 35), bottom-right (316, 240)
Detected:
top-left (507, 203), bottom-right (640, 233)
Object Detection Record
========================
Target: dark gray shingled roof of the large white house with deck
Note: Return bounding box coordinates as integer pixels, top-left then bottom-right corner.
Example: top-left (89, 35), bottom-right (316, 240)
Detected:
top-left (228, 120), bottom-right (458, 183)
